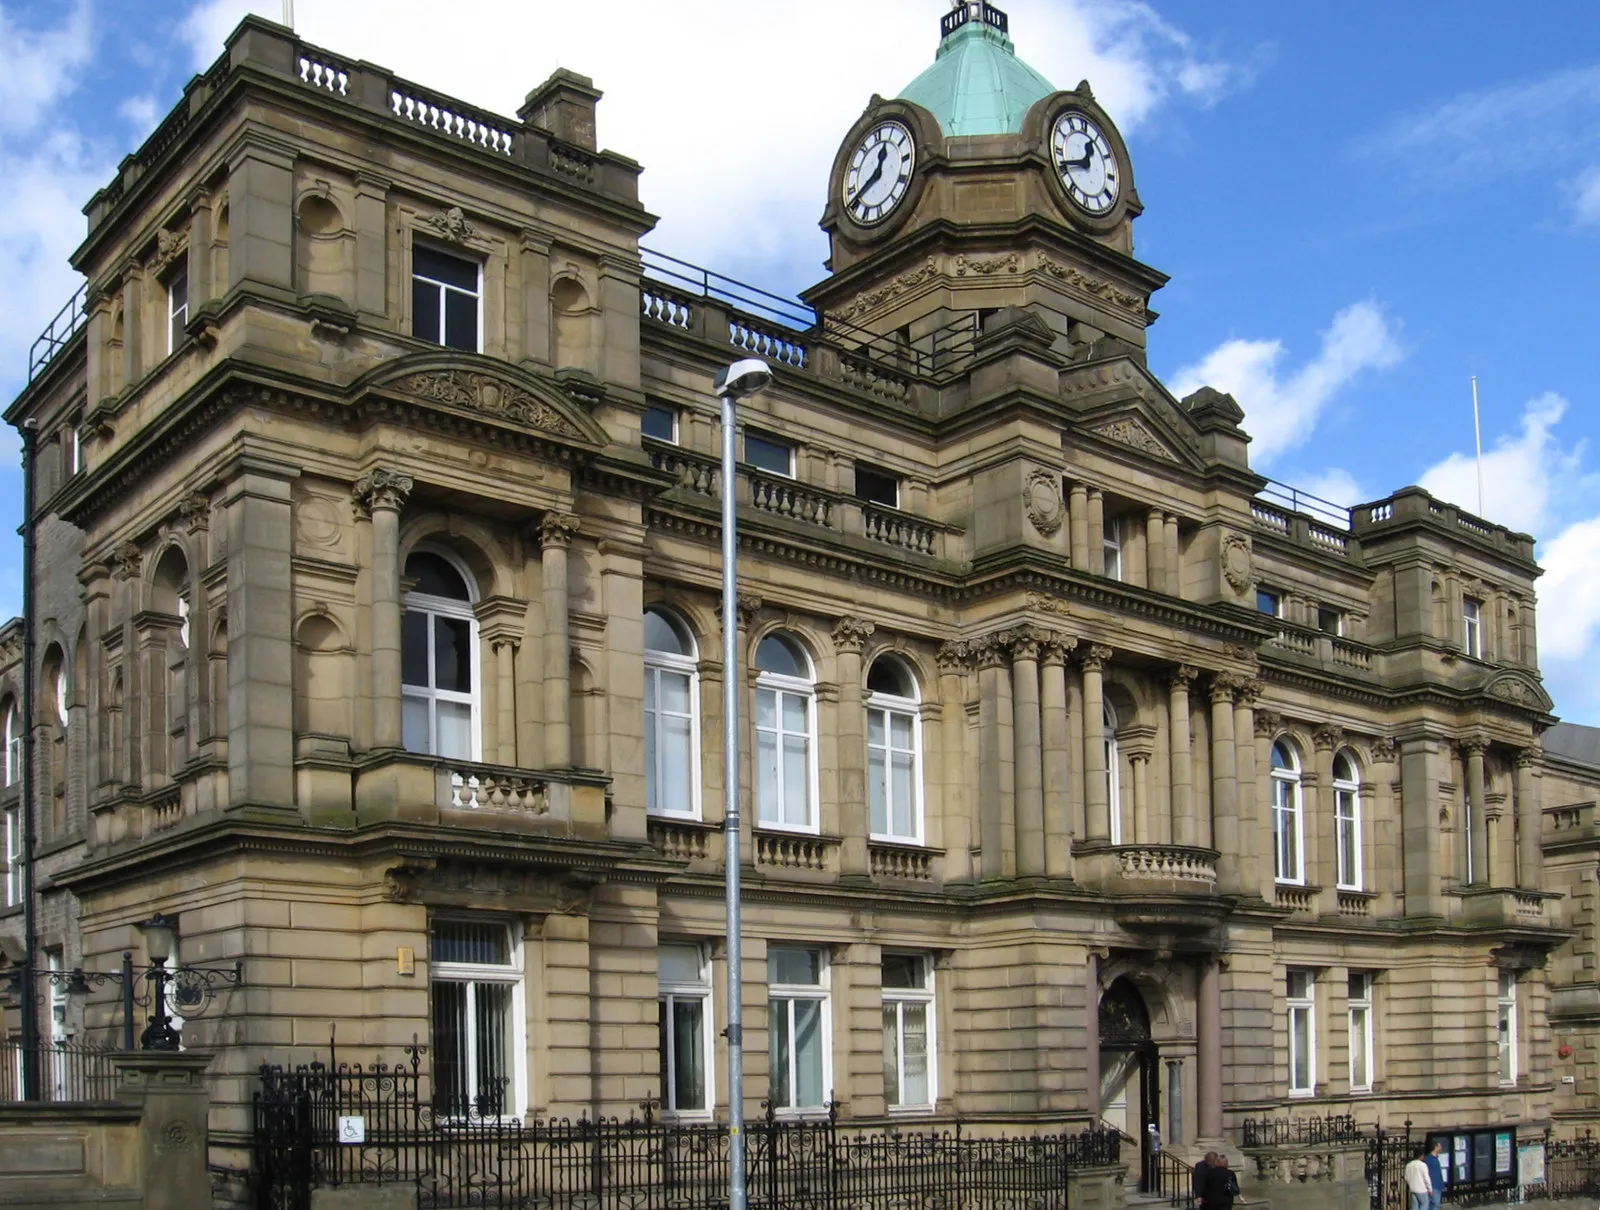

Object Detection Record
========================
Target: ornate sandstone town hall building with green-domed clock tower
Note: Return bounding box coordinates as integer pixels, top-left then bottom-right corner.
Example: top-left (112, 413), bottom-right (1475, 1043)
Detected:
top-left (0, 3), bottom-right (1594, 1203)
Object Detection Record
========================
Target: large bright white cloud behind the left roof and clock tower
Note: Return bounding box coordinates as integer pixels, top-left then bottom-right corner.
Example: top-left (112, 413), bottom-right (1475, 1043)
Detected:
top-left (182, 0), bottom-right (1248, 283)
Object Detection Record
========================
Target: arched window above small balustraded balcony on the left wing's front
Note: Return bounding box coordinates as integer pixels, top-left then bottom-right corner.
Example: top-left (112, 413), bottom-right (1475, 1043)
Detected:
top-left (400, 547), bottom-right (482, 760)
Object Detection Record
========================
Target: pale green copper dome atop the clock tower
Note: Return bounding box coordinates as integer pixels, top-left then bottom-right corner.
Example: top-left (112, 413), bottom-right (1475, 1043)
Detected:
top-left (901, 0), bottom-right (1056, 136)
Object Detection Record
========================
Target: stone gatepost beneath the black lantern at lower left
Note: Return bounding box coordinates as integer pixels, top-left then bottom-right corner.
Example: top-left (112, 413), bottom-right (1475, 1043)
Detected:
top-left (112, 1050), bottom-right (211, 1210)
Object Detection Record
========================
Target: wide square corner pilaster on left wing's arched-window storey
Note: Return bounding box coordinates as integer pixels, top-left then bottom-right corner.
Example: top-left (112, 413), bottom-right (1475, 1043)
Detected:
top-left (222, 455), bottom-right (299, 810)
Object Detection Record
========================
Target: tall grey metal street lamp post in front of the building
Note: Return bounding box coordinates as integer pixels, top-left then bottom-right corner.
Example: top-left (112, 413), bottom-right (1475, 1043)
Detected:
top-left (715, 357), bottom-right (773, 1210)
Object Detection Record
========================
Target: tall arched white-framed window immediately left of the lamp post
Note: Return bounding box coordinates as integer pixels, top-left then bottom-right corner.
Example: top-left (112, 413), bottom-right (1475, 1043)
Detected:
top-left (645, 610), bottom-right (699, 818)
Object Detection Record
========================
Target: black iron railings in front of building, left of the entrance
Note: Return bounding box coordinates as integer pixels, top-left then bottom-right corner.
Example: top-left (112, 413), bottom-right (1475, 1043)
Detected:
top-left (254, 1045), bottom-right (1122, 1210)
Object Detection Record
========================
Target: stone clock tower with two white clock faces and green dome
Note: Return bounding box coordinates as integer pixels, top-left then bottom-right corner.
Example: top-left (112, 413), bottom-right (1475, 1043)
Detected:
top-left (805, 0), bottom-right (1166, 360)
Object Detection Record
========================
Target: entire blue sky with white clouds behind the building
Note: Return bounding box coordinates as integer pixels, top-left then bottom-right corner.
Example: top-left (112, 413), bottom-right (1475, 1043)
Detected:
top-left (0, 0), bottom-right (1600, 723)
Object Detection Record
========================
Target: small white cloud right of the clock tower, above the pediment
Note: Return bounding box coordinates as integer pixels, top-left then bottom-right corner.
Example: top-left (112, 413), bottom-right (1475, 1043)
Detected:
top-left (1170, 301), bottom-right (1405, 467)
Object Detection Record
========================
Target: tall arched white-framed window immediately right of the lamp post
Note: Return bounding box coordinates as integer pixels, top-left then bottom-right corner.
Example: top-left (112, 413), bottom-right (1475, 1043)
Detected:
top-left (755, 634), bottom-right (818, 832)
